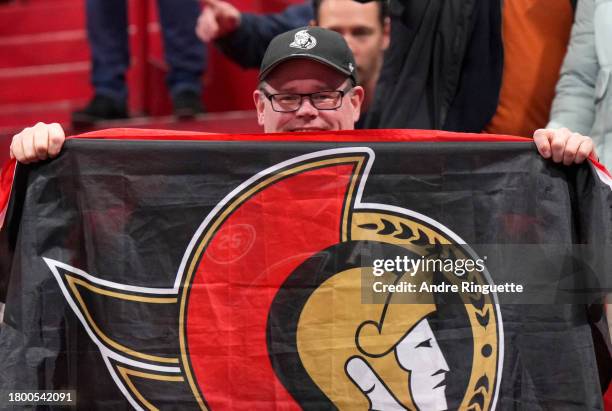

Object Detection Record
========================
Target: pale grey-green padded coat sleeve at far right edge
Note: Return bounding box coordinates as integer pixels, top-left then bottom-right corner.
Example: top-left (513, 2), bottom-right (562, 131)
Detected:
top-left (547, 0), bottom-right (612, 169)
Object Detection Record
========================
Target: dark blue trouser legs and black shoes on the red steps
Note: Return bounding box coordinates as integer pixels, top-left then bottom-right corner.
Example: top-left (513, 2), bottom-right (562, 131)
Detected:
top-left (72, 0), bottom-right (206, 128)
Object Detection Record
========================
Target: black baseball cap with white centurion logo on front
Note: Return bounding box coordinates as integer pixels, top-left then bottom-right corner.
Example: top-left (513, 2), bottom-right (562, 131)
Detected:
top-left (259, 26), bottom-right (357, 85)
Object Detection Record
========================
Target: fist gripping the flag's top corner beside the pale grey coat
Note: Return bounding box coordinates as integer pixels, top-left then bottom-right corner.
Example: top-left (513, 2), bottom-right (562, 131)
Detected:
top-left (533, 128), bottom-right (597, 166)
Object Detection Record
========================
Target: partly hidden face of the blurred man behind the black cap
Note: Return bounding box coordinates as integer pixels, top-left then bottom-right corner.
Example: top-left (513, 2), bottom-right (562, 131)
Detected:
top-left (317, 0), bottom-right (389, 84)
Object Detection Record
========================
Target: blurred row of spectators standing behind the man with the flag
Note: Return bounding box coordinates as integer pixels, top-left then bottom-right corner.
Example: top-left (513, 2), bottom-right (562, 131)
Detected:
top-left (56, 0), bottom-right (612, 165)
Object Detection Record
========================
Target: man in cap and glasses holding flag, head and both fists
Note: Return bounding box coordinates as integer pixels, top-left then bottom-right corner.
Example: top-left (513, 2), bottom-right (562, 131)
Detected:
top-left (10, 27), bottom-right (594, 164)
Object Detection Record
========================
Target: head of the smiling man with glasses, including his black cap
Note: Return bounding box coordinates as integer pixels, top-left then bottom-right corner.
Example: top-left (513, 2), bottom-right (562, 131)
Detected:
top-left (253, 27), bottom-right (364, 133)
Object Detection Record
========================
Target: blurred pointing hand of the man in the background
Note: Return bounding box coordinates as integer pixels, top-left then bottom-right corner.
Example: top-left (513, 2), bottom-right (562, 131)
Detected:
top-left (196, 0), bottom-right (241, 43)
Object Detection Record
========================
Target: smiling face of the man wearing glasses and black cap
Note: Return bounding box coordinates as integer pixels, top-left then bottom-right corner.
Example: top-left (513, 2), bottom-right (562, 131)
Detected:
top-left (253, 58), bottom-right (363, 133)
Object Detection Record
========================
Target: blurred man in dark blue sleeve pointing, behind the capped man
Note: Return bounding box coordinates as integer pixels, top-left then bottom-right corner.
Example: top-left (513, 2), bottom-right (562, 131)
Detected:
top-left (196, 0), bottom-right (390, 122)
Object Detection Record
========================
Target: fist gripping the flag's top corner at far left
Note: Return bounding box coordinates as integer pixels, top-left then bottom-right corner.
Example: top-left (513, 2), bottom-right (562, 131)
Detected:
top-left (10, 123), bottom-right (66, 164)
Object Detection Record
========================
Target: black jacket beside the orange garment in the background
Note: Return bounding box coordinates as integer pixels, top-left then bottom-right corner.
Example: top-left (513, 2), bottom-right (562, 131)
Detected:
top-left (366, 0), bottom-right (503, 132)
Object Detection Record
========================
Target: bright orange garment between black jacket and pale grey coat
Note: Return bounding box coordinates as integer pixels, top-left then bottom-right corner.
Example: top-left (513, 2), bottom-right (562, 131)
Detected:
top-left (484, 0), bottom-right (576, 137)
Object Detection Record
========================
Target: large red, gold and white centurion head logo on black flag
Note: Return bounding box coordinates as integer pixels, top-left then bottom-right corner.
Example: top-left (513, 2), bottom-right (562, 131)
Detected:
top-left (45, 147), bottom-right (504, 410)
